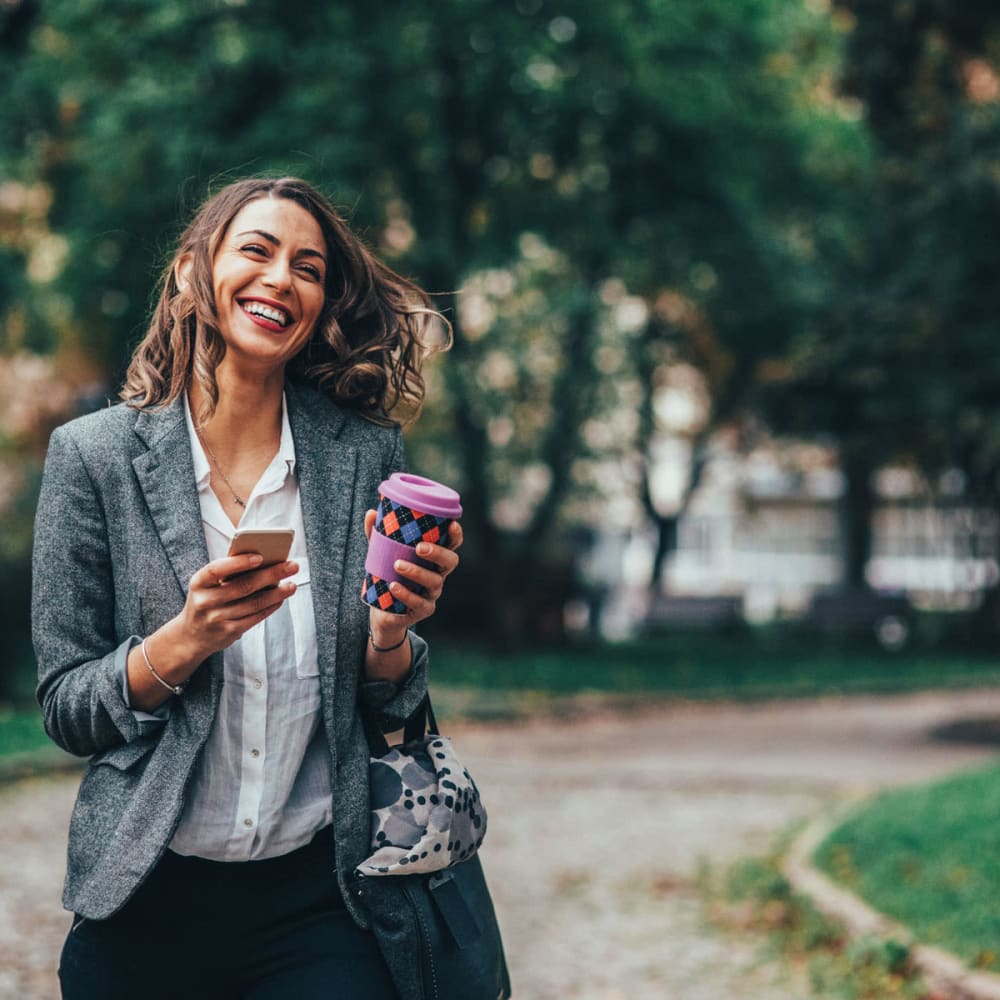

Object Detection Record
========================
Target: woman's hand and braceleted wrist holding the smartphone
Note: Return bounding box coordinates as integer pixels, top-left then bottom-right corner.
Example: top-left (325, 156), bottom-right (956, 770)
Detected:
top-left (127, 554), bottom-right (299, 712)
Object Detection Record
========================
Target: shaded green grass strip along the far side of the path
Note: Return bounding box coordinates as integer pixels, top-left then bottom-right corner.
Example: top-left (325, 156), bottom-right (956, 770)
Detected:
top-left (431, 631), bottom-right (1000, 699)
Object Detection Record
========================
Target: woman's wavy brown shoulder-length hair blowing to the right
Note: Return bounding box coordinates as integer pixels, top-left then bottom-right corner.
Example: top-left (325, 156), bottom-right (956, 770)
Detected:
top-left (121, 177), bottom-right (447, 424)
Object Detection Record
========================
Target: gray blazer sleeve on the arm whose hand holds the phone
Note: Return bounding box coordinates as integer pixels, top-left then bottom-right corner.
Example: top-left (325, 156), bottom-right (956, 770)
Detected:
top-left (31, 427), bottom-right (142, 756)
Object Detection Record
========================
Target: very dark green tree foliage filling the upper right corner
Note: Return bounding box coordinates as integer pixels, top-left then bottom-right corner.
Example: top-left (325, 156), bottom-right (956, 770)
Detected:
top-left (771, 0), bottom-right (1000, 502)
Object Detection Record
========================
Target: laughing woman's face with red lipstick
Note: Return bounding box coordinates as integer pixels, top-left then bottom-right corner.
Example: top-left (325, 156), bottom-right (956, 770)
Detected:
top-left (212, 197), bottom-right (329, 374)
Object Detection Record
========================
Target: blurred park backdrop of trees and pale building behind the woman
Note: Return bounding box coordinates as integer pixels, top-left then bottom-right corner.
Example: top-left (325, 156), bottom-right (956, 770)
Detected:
top-left (0, 0), bottom-right (1000, 706)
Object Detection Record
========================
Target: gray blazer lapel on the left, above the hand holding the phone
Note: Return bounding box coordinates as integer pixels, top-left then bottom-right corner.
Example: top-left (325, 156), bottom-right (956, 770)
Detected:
top-left (132, 399), bottom-right (208, 594)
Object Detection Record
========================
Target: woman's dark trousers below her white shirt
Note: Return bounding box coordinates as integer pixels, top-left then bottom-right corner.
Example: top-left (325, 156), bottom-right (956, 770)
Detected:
top-left (59, 829), bottom-right (396, 1000)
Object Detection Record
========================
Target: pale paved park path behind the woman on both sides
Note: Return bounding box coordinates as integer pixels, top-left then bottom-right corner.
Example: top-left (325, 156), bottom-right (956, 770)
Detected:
top-left (0, 691), bottom-right (1000, 1000)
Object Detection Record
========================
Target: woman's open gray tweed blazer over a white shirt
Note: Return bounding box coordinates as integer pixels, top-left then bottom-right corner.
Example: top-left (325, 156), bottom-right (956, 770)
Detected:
top-left (32, 383), bottom-right (427, 926)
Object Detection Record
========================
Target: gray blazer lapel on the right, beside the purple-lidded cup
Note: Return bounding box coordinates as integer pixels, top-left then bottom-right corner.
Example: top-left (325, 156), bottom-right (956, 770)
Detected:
top-left (285, 383), bottom-right (361, 677)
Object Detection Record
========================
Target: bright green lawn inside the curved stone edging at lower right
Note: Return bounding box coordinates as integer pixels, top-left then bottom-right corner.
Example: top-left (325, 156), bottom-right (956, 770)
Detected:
top-left (816, 762), bottom-right (1000, 970)
